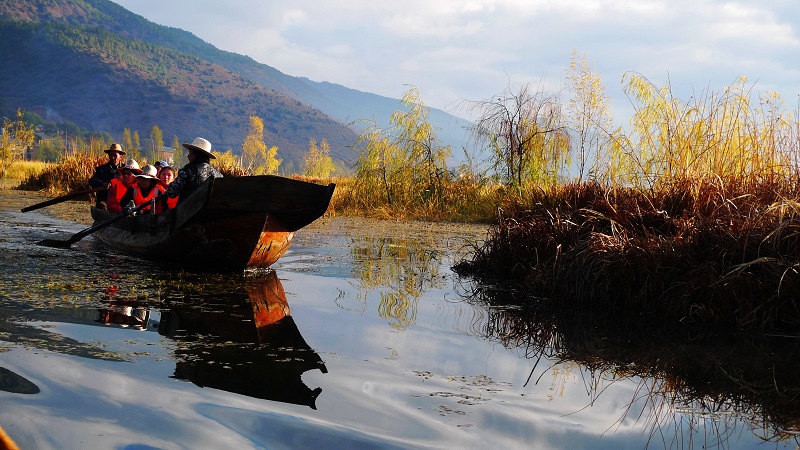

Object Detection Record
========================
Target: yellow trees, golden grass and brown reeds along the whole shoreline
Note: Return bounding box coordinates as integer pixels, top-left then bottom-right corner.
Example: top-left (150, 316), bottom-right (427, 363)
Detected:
top-left (4, 61), bottom-right (800, 332)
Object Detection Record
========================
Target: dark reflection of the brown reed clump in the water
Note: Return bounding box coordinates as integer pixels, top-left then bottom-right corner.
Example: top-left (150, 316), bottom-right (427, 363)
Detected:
top-left (464, 286), bottom-right (800, 448)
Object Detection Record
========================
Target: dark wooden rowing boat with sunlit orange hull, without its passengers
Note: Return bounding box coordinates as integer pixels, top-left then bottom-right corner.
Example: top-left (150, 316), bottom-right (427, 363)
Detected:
top-left (92, 175), bottom-right (335, 272)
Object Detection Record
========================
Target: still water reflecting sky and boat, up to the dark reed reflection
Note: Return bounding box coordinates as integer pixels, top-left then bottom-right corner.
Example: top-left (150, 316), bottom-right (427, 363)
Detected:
top-left (0, 190), bottom-right (795, 449)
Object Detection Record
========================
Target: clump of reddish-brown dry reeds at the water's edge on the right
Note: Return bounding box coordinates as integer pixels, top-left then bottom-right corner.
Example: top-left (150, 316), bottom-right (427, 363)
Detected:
top-left (454, 178), bottom-right (800, 332)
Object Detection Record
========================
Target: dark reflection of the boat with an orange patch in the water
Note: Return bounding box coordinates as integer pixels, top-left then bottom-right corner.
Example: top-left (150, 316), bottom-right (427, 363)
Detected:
top-left (153, 272), bottom-right (327, 409)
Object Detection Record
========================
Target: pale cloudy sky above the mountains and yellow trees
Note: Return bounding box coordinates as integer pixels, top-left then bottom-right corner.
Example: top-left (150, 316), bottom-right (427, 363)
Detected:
top-left (108, 0), bottom-right (800, 125)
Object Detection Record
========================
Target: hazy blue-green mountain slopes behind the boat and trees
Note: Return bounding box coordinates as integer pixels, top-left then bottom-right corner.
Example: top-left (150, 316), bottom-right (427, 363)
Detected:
top-left (0, 0), bottom-right (468, 167)
